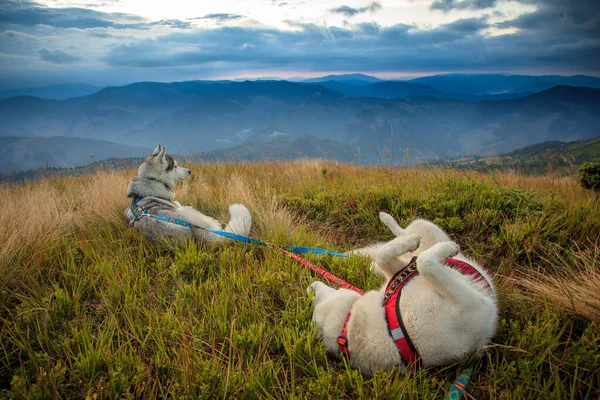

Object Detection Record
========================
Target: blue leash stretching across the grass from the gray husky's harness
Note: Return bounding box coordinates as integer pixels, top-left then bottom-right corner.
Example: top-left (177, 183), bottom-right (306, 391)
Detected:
top-left (129, 197), bottom-right (348, 258)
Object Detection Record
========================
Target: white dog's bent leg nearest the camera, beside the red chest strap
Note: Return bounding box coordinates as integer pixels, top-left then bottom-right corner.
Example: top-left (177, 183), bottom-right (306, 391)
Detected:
top-left (417, 242), bottom-right (481, 304)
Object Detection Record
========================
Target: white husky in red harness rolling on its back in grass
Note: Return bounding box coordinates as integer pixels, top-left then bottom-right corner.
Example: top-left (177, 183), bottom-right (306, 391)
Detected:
top-left (307, 213), bottom-right (498, 375)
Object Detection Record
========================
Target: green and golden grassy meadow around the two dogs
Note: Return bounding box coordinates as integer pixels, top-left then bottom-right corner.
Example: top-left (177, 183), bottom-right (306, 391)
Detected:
top-left (0, 161), bottom-right (600, 399)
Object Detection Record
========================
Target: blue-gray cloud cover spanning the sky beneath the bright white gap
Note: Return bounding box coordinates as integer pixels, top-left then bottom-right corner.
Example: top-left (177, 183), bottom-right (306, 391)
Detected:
top-left (0, 0), bottom-right (600, 86)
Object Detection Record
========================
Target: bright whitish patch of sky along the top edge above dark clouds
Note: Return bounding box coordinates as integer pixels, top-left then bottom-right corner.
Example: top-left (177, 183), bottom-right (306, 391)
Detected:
top-left (40, 0), bottom-right (536, 29)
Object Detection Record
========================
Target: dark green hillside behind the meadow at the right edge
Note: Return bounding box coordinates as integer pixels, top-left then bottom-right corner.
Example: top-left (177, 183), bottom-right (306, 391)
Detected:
top-left (437, 137), bottom-right (600, 175)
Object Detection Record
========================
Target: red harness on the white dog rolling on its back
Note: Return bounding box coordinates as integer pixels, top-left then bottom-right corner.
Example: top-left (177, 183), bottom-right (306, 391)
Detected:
top-left (338, 256), bottom-right (493, 364)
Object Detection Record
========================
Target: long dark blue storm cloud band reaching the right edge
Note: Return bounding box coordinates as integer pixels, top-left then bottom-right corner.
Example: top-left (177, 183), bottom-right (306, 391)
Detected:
top-left (96, 10), bottom-right (600, 73)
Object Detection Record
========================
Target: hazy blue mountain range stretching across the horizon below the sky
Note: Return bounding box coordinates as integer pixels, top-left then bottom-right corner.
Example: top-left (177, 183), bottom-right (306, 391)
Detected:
top-left (0, 74), bottom-right (600, 171)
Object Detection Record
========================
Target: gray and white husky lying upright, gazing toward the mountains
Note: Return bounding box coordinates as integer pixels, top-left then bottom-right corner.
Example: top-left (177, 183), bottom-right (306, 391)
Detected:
top-left (124, 144), bottom-right (252, 244)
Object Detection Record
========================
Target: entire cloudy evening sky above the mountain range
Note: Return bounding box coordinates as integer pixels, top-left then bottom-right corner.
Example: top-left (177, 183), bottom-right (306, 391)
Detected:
top-left (0, 0), bottom-right (600, 89)
